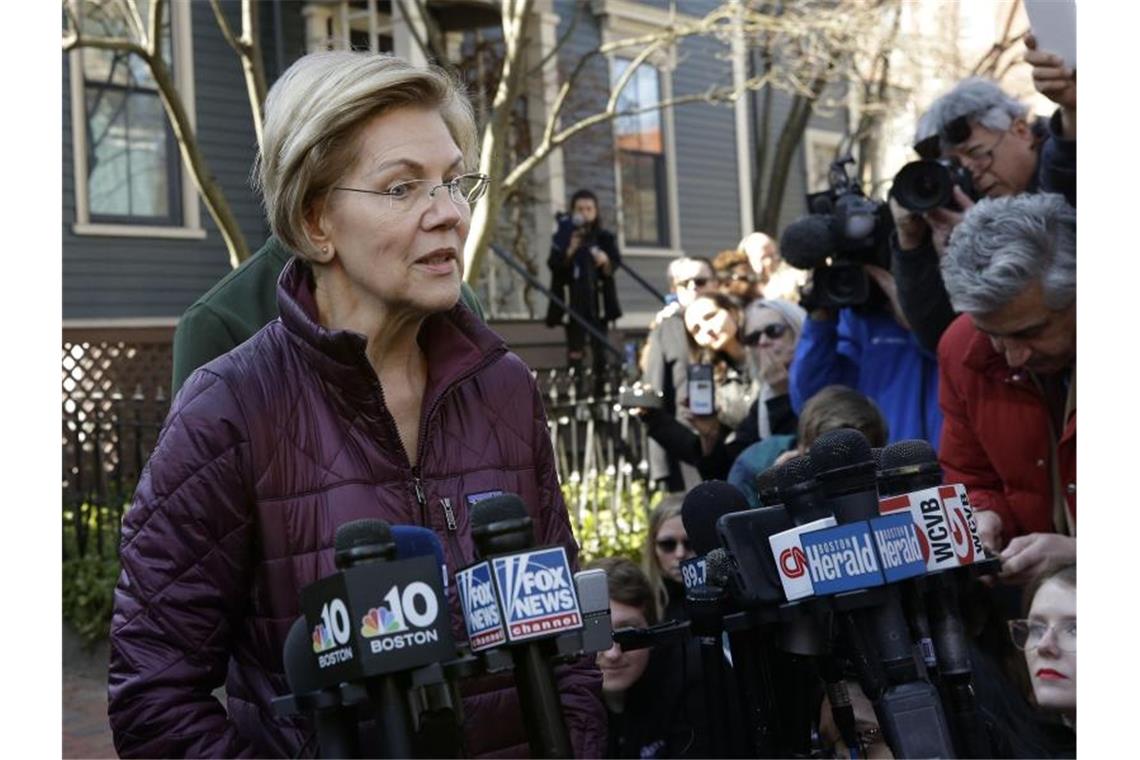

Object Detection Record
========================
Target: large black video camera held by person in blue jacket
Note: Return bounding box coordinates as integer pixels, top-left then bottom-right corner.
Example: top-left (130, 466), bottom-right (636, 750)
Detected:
top-left (780, 155), bottom-right (894, 308)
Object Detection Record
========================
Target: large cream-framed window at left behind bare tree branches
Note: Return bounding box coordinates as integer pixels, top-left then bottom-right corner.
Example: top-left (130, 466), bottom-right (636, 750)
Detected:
top-left (71, 0), bottom-right (204, 237)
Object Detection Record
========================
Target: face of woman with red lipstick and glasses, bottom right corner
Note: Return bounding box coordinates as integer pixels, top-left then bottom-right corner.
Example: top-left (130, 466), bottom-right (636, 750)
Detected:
top-left (1025, 580), bottom-right (1076, 712)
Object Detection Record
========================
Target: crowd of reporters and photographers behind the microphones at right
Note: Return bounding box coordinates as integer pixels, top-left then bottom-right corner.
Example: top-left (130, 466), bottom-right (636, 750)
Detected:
top-left (565, 35), bottom-right (1076, 758)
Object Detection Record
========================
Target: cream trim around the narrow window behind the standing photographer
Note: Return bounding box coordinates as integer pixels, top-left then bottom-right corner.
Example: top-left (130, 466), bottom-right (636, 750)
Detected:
top-left (603, 35), bottom-right (681, 254)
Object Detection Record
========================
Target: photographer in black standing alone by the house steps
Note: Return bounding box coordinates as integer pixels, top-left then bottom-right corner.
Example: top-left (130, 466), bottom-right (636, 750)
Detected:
top-left (546, 189), bottom-right (621, 393)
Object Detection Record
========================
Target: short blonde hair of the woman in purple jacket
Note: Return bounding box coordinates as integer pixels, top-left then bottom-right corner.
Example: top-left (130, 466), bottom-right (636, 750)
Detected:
top-left (253, 50), bottom-right (478, 256)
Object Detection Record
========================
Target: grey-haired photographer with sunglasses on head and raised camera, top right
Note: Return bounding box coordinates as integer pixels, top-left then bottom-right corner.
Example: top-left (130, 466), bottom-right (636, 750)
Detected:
top-left (890, 34), bottom-right (1076, 352)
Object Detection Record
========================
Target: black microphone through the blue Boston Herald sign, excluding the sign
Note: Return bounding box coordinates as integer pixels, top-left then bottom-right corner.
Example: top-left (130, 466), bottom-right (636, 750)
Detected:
top-left (811, 428), bottom-right (954, 758)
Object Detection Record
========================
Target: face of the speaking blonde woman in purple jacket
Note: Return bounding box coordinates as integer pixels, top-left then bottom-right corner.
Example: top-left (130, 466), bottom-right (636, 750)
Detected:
top-left (310, 107), bottom-right (471, 313)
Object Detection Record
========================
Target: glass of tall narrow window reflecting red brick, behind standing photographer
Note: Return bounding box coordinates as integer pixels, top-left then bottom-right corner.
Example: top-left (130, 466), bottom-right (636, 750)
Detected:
top-left (611, 58), bottom-right (669, 247)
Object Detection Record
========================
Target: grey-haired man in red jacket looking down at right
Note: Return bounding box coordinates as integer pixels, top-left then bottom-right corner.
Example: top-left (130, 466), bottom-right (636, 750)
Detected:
top-left (938, 194), bottom-right (1076, 583)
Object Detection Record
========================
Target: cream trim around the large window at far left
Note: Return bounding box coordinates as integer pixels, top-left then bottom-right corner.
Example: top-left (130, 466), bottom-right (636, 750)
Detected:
top-left (68, 0), bottom-right (206, 240)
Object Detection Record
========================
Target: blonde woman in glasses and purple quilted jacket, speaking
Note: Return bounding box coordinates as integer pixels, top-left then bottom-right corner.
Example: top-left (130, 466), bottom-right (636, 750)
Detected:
top-left (108, 51), bottom-right (605, 758)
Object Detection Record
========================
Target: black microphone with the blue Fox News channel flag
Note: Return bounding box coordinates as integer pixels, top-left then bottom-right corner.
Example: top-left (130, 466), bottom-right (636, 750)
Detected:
top-left (471, 493), bottom-right (583, 758)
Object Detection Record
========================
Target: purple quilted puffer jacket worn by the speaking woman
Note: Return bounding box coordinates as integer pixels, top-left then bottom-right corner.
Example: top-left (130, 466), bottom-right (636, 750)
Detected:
top-left (108, 261), bottom-right (605, 758)
